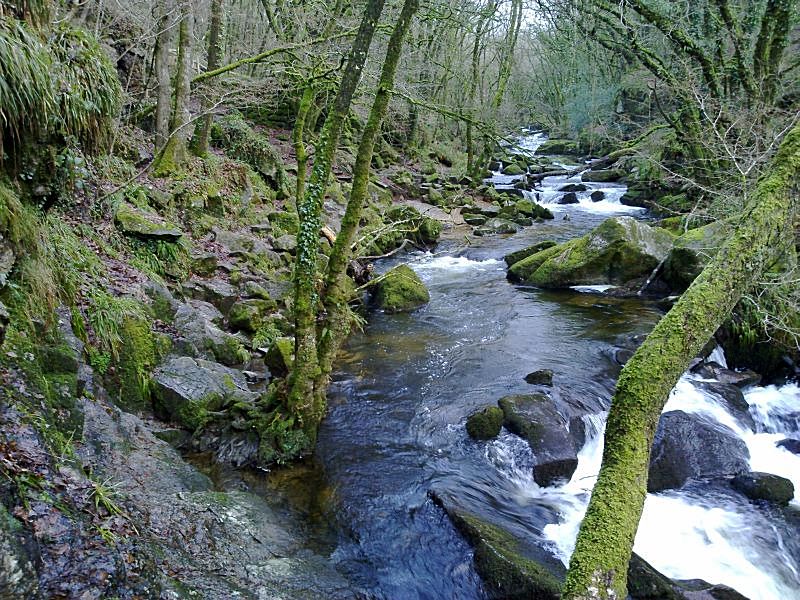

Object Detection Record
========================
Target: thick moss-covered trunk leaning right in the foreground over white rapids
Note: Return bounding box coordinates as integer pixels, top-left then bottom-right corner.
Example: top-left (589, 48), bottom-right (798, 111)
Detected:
top-left (562, 125), bottom-right (800, 600)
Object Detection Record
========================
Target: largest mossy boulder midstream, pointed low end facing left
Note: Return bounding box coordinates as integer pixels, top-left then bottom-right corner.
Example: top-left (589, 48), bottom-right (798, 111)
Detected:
top-left (508, 217), bottom-right (672, 288)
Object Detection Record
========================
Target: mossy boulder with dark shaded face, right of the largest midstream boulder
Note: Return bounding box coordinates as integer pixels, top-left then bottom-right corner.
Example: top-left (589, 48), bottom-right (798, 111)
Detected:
top-left (661, 221), bottom-right (731, 292)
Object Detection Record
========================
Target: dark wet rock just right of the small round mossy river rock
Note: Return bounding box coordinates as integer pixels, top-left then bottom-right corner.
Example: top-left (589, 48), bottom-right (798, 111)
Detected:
top-left (498, 394), bottom-right (578, 486)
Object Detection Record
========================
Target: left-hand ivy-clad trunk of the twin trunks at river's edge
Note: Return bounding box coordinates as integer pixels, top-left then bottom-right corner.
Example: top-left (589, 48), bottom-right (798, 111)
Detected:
top-left (287, 0), bottom-right (384, 443)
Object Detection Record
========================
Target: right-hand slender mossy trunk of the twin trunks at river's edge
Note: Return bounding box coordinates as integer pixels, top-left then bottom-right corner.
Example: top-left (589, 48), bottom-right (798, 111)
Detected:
top-left (314, 0), bottom-right (419, 404)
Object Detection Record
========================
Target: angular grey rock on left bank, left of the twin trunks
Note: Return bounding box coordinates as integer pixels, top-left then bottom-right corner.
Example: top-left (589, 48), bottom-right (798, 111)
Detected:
top-left (152, 356), bottom-right (258, 430)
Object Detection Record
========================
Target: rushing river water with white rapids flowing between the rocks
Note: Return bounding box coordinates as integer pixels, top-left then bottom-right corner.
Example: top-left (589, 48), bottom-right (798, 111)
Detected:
top-left (318, 138), bottom-right (800, 600)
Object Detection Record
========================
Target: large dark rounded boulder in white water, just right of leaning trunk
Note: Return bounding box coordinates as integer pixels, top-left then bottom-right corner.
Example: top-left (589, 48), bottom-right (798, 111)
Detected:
top-left (647, 410), bottom-right (750, 492)
